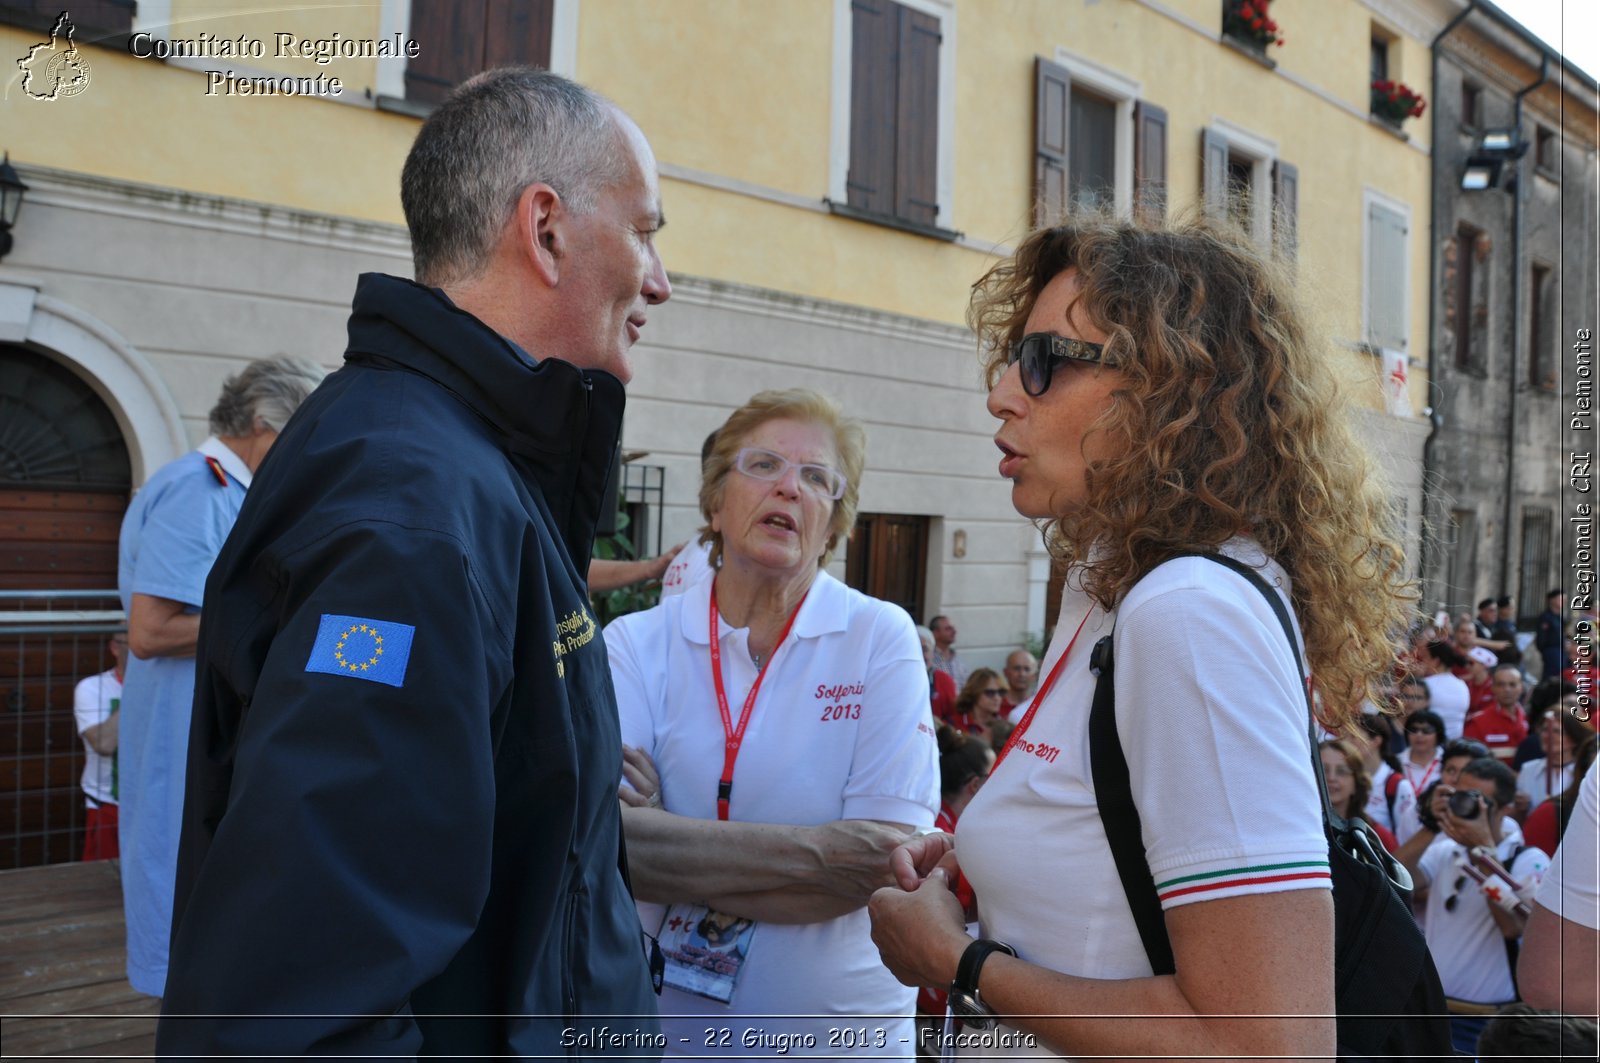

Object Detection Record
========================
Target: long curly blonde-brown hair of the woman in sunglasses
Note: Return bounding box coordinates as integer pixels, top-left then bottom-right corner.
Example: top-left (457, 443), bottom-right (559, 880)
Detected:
top-left (968, 216), bottom-right (1416, 728)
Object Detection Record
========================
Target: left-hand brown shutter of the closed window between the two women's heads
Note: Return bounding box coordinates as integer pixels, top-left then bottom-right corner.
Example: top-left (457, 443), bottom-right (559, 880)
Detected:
top-left (845, 0), bottom-right (899, 215)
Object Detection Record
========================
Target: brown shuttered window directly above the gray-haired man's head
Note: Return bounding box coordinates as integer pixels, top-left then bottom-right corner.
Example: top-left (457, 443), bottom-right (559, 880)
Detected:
top-left (405, 0), bottom-right (555, 106)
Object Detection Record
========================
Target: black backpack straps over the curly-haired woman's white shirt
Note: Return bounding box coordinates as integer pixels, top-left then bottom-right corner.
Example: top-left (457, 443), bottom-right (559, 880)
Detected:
top-left (1090, 552), bottom-right (1318, 975)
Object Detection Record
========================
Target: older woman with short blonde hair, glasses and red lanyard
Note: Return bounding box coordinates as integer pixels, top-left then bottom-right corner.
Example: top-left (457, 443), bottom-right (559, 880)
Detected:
top-left (605, 391), bottom-right (939, 1058)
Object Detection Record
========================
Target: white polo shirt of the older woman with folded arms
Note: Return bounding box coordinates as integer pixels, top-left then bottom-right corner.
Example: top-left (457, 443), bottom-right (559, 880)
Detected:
top-left (605, 572), bottom-right (939, 1057)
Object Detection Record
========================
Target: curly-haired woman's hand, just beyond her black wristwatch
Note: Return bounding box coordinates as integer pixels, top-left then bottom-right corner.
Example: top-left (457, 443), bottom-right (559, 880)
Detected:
top-left (867, 864), bottom-right (971, 986)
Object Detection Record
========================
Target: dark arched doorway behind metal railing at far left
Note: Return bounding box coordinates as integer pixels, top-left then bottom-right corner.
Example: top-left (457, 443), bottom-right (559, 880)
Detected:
top-left (0, 344), bottom-right (133, 868)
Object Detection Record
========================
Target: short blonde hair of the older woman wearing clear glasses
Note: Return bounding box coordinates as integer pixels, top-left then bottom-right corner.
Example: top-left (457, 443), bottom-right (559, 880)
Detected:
top-left (699, 387), bottom-right (867, 568)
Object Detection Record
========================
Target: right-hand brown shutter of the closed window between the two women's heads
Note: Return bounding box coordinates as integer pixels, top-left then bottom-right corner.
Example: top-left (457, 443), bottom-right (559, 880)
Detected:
top-left (894, 5), bottom-right (942, 226)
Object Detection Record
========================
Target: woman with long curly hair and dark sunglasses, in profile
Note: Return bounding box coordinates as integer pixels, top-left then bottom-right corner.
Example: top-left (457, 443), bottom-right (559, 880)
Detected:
top-left (870, 219), bottom-right (1413, 1058)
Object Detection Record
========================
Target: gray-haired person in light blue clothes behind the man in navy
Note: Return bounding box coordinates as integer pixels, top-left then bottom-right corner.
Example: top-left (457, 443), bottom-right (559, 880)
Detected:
top-left (117, 359), bottom-right (325, 997)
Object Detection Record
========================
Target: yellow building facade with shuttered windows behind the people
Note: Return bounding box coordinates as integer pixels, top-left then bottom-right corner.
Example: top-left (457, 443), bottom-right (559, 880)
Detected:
top-left (0, 0), bottom-right (1462, 663)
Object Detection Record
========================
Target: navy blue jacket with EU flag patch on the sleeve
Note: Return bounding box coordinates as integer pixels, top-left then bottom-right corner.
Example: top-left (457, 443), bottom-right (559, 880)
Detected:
top-left (157, 274), bottom-right (658, 1055)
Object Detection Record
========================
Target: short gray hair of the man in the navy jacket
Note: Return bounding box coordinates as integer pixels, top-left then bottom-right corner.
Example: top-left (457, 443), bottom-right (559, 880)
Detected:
top-left (400, 67), bottom-right (627, 287)
